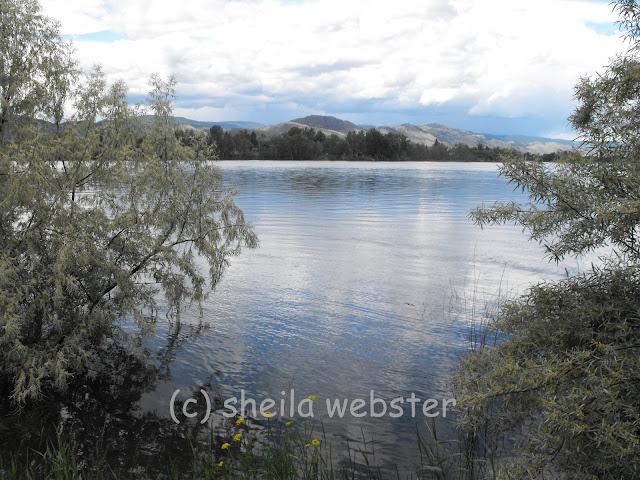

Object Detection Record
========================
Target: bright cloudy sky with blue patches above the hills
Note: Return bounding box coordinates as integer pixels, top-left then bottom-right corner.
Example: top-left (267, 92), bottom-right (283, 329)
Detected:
top-left (42, 0), bottom-right (624, 138)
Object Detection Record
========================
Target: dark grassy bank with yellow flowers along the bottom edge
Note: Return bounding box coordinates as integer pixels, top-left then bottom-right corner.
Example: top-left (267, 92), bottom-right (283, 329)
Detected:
top-left (0, 412), bottom-right (495, 480)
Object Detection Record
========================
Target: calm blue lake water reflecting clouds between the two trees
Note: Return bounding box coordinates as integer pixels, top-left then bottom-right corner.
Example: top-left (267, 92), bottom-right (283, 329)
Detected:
top-left (142, 162), bottom-right (572, 464)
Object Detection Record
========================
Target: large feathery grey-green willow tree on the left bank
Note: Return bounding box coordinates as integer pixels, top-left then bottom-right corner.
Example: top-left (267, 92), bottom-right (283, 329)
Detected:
top-left (0, 0), bottom-right (257, 405)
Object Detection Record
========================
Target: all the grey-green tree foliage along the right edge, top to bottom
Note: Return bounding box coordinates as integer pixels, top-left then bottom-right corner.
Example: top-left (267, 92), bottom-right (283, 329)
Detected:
top-left (455, 0), bottom-right (640, 479)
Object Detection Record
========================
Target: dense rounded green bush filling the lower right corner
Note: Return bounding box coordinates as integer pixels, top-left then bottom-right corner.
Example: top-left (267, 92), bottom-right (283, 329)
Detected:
top-left (455, 268), bottom-right (640, 479)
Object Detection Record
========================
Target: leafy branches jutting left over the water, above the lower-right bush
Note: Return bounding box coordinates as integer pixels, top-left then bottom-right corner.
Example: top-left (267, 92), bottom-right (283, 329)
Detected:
top-left (472, 154), bottom-right (640, 262)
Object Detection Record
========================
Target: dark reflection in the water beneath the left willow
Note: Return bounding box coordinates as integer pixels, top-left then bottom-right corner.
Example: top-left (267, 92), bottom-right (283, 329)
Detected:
top-left (0, 322), bottom-right (222, 478)
